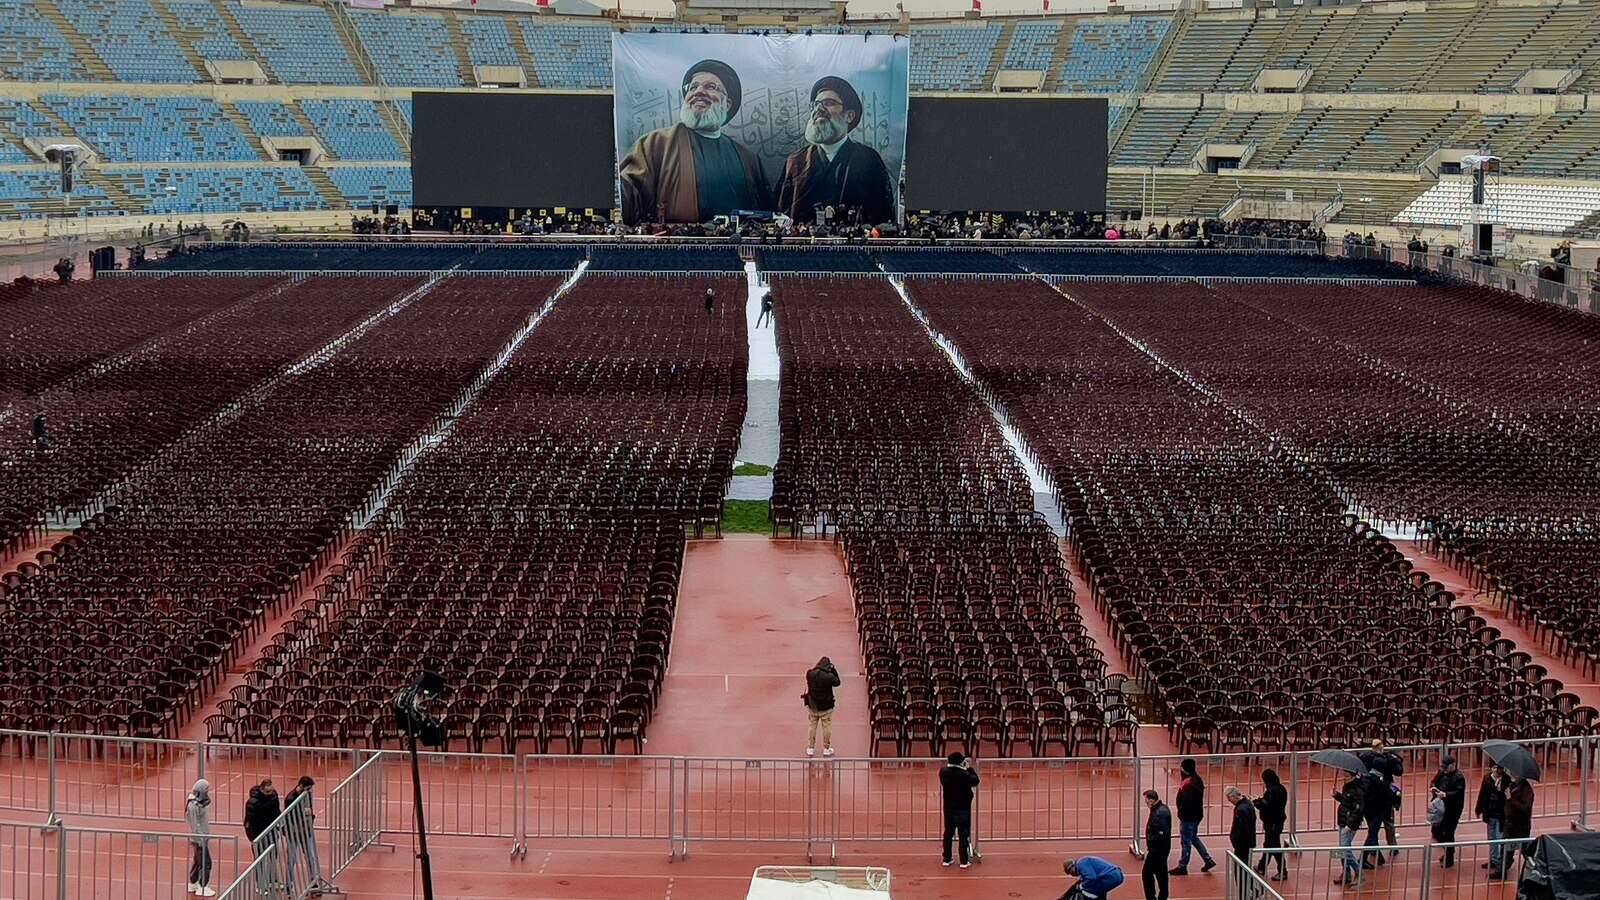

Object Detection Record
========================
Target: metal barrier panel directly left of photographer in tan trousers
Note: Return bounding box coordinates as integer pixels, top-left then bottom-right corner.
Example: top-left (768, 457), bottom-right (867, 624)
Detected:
top-left (678, 759), bottom-right (835, 855)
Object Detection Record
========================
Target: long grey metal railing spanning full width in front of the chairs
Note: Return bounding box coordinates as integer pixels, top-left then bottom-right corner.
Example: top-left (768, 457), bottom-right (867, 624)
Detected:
top-left (0, 732), bottom-right (1600, 864)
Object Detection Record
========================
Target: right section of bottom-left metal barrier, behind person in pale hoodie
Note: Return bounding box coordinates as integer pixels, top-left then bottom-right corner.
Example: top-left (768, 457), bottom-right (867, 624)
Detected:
top-left (59, 828), bottom-right (242, 900)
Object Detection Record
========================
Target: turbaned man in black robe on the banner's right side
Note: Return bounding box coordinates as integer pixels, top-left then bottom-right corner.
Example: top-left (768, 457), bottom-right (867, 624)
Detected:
top-left (778, 75), bottom-right (894, 224)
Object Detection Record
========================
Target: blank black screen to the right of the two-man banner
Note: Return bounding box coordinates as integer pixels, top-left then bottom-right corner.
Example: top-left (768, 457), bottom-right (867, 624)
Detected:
top-left (906, 96), bottom-right (1109, 213)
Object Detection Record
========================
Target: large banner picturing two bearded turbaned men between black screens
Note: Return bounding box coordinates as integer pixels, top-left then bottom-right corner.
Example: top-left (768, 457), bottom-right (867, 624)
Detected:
top-left (611, 32), bottom-right (910, 224)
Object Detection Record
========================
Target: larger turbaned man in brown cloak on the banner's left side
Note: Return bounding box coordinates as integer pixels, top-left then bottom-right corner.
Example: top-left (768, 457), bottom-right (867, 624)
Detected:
top-left (618, 59), bottom-right (773, 224)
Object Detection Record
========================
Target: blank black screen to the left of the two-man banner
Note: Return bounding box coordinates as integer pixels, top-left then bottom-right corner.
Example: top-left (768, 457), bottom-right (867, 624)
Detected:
top-left (411, 91), bottom-right (616, 210)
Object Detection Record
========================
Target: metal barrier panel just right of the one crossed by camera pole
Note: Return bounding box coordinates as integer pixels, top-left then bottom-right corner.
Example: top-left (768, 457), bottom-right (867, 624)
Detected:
top-left (522, 756), bottom-right (683, 854)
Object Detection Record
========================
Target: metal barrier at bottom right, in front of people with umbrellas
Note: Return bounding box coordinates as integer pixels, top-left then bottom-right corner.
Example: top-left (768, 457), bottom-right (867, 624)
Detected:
top-left (1226, 830), bottom-right (1528, 900)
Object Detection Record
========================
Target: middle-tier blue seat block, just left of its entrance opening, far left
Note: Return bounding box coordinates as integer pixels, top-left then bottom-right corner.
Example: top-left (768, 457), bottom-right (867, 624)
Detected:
top-left (43, 94), bottom-right (261, 162)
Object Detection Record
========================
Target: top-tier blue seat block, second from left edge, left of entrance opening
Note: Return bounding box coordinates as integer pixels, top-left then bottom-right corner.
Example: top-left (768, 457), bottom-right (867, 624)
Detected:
top-left (56, 0), bottom-right (200, 83)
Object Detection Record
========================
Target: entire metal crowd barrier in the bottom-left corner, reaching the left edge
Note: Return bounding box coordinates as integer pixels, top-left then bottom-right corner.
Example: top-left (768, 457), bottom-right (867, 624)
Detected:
top-left (0, 823), bottom-right (240, 900)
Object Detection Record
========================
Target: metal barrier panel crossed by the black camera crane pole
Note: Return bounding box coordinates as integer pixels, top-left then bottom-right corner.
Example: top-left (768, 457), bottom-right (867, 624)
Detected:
top-left (372, 749), bottom-right (522, 844)
